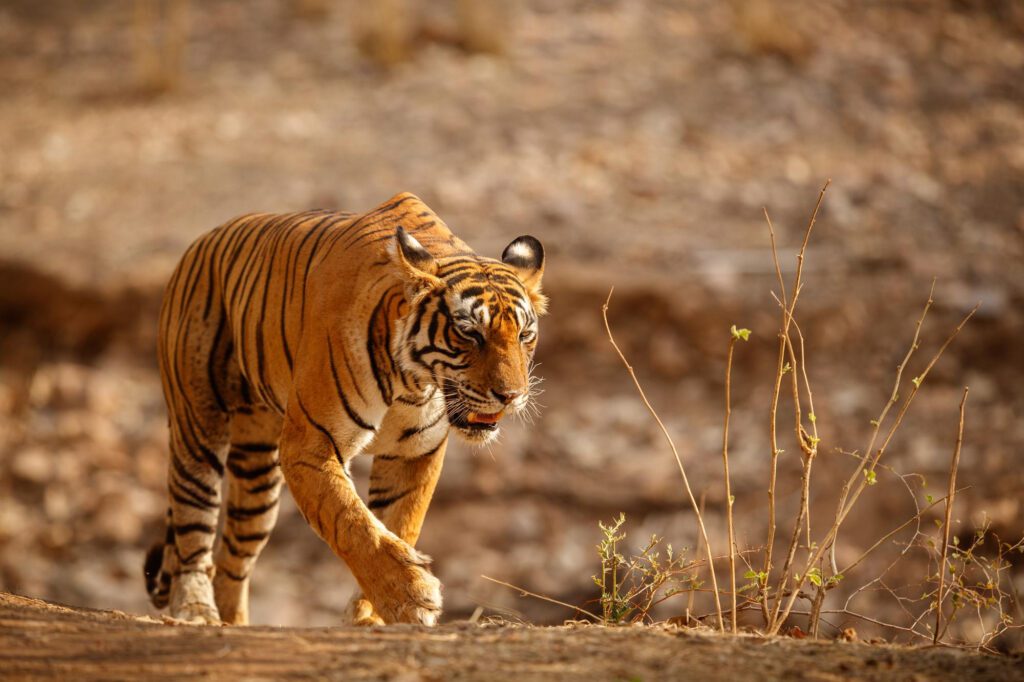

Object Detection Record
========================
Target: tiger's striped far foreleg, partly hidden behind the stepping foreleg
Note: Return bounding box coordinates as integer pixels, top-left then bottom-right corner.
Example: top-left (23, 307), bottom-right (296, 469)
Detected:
top-left (349, 434), bottom-right (447, 625)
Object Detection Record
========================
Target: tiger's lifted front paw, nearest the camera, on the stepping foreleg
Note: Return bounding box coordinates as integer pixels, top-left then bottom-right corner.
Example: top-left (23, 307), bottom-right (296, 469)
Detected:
top-left (364, 543), bottom-right (441, 626)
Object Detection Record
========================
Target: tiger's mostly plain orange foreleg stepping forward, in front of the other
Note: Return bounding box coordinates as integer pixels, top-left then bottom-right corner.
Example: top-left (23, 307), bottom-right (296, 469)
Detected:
top-left (281, 399), bottom-right (441, 625)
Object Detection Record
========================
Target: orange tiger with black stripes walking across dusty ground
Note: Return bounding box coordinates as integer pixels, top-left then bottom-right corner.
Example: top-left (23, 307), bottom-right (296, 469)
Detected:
top-left (143, 193), bottom-right (548, 626)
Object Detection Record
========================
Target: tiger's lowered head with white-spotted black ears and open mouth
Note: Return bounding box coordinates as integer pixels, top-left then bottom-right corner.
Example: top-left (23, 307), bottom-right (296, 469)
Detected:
top-left (392, 227), bottom-right (547, 444)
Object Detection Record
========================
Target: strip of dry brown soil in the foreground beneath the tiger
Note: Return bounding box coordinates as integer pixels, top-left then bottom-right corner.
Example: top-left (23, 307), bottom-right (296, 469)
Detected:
top-left (0, 594), bottom-right (1024, 682)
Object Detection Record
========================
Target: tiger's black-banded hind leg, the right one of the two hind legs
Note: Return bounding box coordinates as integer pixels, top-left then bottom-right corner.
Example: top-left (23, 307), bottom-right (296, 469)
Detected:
top-left (213, 408), bottom-right (284, 625)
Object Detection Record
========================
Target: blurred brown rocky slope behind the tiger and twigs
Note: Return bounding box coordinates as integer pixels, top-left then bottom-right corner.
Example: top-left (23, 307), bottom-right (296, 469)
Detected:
top-left (0, 0), bottom-right (1024, 634)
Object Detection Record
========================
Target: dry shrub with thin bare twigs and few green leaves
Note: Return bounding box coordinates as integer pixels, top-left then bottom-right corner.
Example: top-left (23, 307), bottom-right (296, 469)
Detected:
top-left (491, 182), bottom-right (1024, 651)
